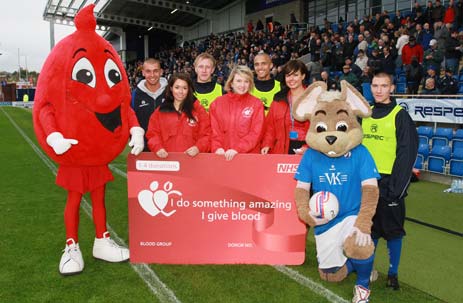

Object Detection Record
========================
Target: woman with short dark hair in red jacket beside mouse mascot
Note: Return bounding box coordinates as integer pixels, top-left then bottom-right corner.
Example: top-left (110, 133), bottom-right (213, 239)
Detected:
top-left (261, 60), bottom-right (310, 154)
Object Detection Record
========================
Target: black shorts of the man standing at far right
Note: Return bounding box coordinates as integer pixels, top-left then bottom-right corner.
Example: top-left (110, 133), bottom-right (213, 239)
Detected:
top-left (371, 197), bottom-right (405, 240)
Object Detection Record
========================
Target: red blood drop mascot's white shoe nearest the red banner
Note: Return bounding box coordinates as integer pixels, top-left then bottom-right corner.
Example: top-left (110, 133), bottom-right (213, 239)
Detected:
top-left (93, 232), bottom-right (130, 262)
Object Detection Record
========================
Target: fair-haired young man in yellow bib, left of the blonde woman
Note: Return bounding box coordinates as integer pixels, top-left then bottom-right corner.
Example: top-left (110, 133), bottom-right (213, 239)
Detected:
top-left (193, 53), bottom-right (223, 111)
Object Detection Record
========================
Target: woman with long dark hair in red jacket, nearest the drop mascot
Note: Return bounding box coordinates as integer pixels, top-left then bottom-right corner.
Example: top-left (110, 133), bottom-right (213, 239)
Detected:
top-left (146, 73), bottom-right (211, 158)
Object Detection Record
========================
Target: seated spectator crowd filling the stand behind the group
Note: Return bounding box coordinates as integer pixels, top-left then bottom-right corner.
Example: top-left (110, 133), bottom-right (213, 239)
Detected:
top-left (128, 0), bottom-right (463, 94)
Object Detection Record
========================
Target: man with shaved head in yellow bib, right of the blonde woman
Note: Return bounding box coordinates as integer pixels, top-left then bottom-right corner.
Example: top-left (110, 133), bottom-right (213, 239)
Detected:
top-left (251, 52), bottom-right (281, 114)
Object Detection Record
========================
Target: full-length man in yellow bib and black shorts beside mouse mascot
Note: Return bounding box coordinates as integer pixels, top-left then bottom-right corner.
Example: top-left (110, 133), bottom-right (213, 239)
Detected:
top-left (362, 72), bottom-right (418, 290)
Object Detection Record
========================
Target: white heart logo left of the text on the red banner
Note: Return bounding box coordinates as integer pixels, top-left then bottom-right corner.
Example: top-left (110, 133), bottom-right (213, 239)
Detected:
top-left (138, 181), bottom-right (182, 217)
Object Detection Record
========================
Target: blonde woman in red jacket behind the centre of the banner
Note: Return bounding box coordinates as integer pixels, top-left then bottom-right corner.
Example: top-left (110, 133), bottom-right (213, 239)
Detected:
top-left (209, 65), bottom-right (264, 160)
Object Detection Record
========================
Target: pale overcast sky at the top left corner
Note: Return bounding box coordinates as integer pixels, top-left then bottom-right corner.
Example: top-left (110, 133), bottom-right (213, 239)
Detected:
top-left (0, 0), bottom-right (77, 72)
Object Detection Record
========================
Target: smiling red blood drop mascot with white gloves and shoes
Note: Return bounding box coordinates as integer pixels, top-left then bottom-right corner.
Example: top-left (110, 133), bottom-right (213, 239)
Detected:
top-left (33, 5), bottom-right (144, 275)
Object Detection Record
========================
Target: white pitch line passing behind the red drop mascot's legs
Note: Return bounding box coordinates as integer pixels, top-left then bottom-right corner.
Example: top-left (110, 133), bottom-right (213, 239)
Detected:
top-left (1, 108), bottom-right (181, 303)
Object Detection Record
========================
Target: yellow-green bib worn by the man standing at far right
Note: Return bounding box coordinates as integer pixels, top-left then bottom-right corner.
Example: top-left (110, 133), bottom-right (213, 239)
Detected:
top-left (362, 105), bottom-right (402, 174)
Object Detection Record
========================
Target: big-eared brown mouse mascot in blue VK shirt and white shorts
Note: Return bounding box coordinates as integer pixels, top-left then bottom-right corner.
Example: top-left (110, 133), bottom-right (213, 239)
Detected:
top-left (293, 81), bottom-right (380, 303)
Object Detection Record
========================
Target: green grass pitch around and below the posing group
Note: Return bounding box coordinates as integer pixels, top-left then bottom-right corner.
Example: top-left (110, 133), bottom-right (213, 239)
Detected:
top-left (0, 107), bottom-right (463, 303)
